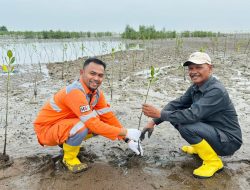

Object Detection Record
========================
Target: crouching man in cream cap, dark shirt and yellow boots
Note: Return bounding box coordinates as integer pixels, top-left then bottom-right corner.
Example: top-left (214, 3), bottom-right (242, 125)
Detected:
top-left (141, 52), bottom-right (242, 178)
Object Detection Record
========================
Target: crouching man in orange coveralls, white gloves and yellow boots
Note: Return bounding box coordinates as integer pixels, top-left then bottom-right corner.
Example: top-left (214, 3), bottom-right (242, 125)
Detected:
top-left (34, 58), bottom-right (143, 173)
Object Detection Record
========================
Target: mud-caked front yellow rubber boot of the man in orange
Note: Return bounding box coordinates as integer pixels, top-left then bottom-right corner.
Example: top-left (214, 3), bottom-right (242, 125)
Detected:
top-left (63, 143), bottom-right (88, 173)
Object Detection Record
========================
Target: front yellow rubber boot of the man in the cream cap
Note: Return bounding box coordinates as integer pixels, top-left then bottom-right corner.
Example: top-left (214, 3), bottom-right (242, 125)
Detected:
top-left (192, 139), bottom-right (223, 178)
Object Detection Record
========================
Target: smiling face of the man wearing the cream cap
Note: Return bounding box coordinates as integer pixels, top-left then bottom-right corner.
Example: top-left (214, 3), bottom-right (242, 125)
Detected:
top-left (188, 64), bottom-right (213, 86)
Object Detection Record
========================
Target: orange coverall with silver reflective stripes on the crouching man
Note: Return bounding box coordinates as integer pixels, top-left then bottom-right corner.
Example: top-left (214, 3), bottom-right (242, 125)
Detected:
top-left (34, 80), bottom-right (122, 146)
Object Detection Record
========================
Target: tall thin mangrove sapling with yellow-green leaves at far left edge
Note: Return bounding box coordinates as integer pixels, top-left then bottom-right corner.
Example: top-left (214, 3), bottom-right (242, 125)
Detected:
top-left (2, 50), bottom-right (15, 161)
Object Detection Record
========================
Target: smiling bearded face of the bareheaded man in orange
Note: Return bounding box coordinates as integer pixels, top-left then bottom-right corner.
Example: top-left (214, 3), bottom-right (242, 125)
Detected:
top-left (80, 62), bottom-right (104, 91)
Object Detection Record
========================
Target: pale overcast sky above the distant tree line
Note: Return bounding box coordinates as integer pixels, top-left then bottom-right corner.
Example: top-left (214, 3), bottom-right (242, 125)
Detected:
top-left (0, 0), bottom-right (250, 32)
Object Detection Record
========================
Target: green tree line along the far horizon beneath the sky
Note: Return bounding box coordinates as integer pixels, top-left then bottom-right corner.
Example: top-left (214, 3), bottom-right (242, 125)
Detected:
top-left (0, 25), bottom-right (223, 40)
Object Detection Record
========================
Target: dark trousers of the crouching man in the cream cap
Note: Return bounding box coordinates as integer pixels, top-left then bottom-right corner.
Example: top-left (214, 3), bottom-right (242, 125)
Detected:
top-left (172, 122), bottom-right (241, 156)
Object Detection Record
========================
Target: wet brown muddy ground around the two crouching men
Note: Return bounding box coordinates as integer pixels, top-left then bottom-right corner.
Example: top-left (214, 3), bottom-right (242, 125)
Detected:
top-left (0, 38), bottom-right (250, 190)
